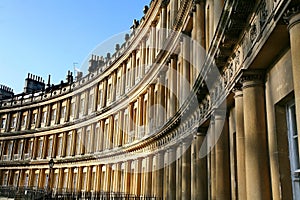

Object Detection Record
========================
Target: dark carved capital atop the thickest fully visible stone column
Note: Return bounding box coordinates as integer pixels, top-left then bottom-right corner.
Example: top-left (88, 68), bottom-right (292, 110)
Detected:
top-left (240, 70), bottom-right (265, 89)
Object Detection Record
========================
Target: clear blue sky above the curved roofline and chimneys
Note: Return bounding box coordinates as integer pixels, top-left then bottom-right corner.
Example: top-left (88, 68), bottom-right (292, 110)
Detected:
top-left (0, 0), bottom-right (150, 93)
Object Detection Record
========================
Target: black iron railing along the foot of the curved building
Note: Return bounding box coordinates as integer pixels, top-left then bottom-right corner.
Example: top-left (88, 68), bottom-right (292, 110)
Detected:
top-left (0, 186), bottom-right (160, 200)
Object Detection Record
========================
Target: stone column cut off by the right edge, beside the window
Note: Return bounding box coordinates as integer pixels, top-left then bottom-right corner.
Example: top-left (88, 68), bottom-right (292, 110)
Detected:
top-left (286, 5), bottom-right (300, 159)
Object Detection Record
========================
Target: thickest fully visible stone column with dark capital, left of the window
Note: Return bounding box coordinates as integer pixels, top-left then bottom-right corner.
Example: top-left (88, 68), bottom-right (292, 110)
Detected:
top-left (243, 72), bottom-right (271, 200)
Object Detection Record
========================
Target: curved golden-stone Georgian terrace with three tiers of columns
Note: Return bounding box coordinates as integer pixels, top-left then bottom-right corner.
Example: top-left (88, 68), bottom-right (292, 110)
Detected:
top-left (0, 0), bottom-right (300, 200)
